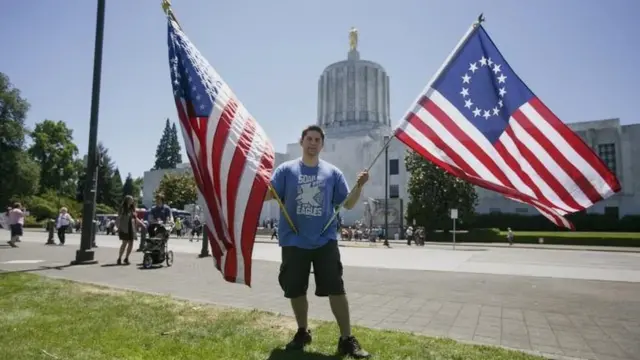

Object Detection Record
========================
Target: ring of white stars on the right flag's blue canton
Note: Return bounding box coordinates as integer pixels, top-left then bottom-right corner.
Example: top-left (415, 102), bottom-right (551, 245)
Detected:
top-left (460, 56), bottom-right (507, 120)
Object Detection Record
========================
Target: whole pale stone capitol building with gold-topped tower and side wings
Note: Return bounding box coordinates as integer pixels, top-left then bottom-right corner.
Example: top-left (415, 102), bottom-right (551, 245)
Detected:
top-left (143, 29), bottom-right (640, 234)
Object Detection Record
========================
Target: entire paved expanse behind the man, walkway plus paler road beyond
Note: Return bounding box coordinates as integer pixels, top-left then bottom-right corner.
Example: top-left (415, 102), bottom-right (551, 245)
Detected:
top-left (0, 232), bottom-right (640, 360)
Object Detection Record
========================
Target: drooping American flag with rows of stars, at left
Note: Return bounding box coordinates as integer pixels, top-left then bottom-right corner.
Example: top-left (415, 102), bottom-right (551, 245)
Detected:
top-left (168, 18), bottom-right (274, 286)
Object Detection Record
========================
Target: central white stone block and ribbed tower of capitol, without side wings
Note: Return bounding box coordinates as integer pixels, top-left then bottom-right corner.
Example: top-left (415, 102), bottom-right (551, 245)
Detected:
top-left (261, 32), bottom-right (407, 233)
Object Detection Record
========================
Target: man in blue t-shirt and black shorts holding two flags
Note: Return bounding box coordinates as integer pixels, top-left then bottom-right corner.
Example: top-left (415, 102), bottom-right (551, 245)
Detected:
top-left (265, 126), bottom-right (370, 359)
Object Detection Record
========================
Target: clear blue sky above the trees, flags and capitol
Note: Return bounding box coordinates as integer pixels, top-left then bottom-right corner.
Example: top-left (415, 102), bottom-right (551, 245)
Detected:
top-left (0, 0), bottom-right (640, 176)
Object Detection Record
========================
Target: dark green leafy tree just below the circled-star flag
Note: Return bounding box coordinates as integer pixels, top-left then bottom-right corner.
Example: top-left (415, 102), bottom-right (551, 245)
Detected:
top-left (405, 151), bottom-right (478, 230)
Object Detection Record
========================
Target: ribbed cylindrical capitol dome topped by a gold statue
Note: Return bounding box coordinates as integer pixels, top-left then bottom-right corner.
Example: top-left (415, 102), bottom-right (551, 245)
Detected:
top-left (317, 28), bottom-right (391, 137)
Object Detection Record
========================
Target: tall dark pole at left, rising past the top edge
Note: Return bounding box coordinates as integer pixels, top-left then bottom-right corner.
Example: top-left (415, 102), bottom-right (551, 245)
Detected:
top-left (71, 0), bottom-right (106, 265)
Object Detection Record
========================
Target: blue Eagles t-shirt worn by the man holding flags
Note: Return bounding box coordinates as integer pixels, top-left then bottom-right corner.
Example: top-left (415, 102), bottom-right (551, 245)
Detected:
top-left (271, 159), bottom-right (349, 249)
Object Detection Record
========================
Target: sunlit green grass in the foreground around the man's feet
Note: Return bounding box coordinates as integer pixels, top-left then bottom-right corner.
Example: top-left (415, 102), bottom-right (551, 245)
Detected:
top-left (0, 273), bottom-right (541, 360)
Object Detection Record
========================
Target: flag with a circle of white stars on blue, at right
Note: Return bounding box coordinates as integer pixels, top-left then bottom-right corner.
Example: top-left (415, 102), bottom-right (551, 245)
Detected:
top-left (395, 23), bottom-right (620, 229)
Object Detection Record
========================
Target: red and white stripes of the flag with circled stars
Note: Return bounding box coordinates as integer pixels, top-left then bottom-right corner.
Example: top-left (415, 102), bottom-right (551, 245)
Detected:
top-left (396, 88), bottom-right (620, 228)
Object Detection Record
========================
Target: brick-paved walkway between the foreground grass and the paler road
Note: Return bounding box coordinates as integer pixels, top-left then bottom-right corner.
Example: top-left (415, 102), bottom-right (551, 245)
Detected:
top-left (0, 243), bottom-right (640, 360)
